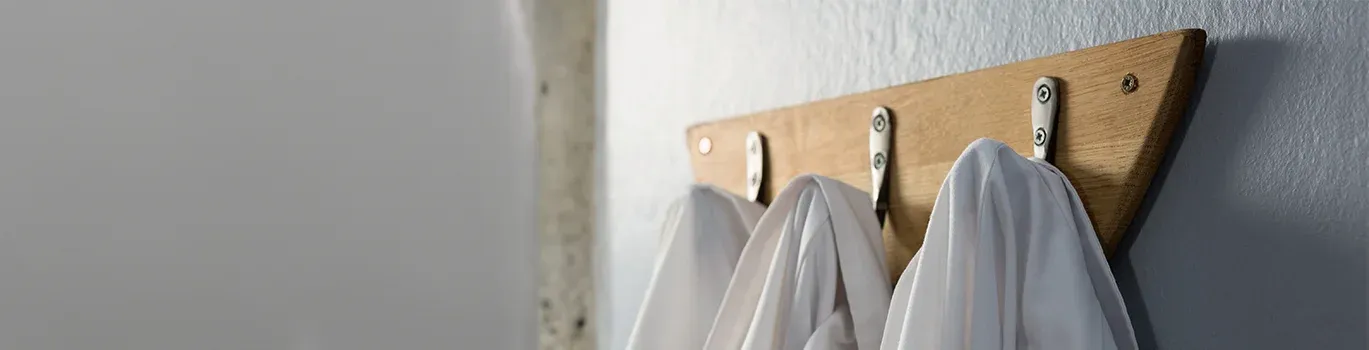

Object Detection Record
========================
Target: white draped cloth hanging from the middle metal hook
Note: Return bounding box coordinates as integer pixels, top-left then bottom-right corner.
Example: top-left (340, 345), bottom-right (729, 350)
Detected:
top-left (704, 175), bottom-right (890, 350)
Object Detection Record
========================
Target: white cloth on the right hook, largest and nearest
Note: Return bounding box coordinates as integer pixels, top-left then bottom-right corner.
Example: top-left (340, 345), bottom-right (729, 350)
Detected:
top-left (882, 138), bottom-right (1136, 350)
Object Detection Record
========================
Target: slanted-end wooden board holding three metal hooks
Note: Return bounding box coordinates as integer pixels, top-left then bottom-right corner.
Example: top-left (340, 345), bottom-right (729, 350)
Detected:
top-left (687, 29), bottom-right (1206, 280)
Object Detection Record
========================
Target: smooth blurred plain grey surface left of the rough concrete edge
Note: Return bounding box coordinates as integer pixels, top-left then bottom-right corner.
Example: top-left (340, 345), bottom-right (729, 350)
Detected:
top-left (0, 0), bottom-right (535, 350)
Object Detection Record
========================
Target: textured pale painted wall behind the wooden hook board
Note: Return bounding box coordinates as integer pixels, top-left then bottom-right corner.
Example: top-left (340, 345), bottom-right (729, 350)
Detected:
top-left (600, 0), bottom-right (1369, 349)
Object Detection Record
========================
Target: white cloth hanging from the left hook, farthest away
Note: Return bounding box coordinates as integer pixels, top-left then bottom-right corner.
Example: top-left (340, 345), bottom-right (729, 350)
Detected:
top-left (627, 185), bottom-right (765, 350)
